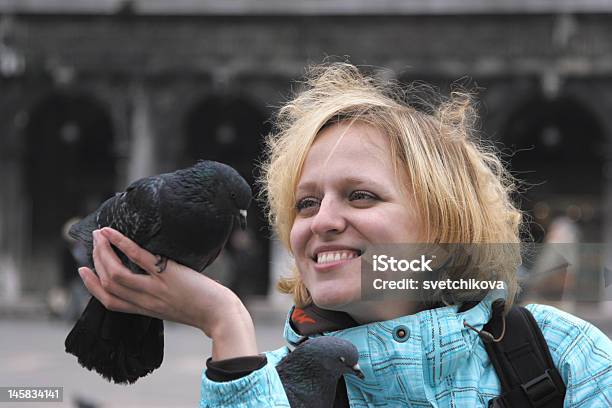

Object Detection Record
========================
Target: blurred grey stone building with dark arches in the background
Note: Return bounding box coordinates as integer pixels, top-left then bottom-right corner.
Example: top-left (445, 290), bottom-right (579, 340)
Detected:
top-left (0, 0), bottom-right (612, 298)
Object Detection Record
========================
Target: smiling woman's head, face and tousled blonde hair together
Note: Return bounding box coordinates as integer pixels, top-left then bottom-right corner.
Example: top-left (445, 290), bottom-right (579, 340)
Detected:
top-left (262, 64), bottom-right (522, 316)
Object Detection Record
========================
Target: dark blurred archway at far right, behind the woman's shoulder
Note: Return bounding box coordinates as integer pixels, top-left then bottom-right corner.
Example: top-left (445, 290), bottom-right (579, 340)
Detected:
top-left (503, 94), bottom-right (606, 242)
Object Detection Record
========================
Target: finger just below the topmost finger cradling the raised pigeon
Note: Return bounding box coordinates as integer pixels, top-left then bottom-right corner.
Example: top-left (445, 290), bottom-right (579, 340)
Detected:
top-left (93, 231), bottom-right (157, 295)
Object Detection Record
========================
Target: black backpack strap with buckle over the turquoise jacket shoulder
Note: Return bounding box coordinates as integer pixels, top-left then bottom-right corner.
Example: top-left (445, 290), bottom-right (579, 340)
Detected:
top-left (481, 304), bottom-right (565, 408)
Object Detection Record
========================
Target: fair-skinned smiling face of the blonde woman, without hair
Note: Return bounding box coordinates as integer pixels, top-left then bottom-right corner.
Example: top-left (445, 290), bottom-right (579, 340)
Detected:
top-left (290, 122), bottom-right (422, 321)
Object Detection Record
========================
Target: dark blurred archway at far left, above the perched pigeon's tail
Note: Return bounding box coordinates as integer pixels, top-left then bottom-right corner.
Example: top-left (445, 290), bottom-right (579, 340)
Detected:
top-left (22, 90), bottom-right (116, 288)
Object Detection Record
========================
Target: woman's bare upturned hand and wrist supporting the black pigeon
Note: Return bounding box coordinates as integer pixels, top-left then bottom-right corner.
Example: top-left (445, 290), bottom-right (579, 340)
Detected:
top-left (79, 228), bottom-right (257, 360)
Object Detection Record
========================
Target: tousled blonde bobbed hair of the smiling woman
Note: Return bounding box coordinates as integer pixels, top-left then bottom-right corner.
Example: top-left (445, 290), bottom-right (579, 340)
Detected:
top-left (259, 63), bottom-right (522, 307)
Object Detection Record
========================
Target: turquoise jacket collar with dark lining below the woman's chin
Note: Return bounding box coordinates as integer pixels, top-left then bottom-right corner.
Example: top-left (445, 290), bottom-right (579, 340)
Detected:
top-left (284, 290), bottom-right (506, 385)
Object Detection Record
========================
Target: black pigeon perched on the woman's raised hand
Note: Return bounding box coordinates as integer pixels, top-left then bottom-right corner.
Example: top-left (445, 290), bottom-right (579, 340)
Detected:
top-left (65, 161), bottom-right (251, 383)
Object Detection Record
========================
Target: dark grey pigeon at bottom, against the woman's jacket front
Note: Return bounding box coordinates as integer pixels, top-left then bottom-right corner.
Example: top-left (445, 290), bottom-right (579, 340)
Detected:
top-left (276, 336), bottom-right (364, 408)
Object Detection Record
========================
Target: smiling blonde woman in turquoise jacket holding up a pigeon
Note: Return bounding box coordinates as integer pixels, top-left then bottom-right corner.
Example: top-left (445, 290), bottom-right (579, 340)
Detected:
top-left (83, 64), bottom-right (612, 408)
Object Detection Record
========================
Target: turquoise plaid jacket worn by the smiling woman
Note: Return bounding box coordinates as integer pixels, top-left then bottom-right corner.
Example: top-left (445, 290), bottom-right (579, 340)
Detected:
top-left (200, 293), bottom-right (612, 407)
